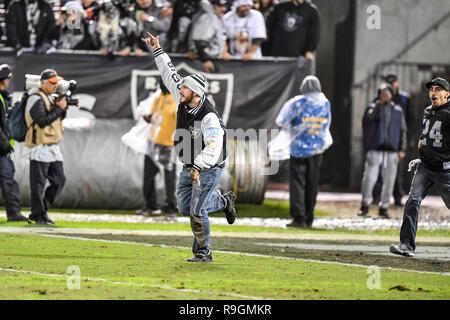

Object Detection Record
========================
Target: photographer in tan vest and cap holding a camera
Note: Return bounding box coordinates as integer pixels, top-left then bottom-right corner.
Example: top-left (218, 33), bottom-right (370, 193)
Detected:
top-left (25, 69), bottom-right (68, 224)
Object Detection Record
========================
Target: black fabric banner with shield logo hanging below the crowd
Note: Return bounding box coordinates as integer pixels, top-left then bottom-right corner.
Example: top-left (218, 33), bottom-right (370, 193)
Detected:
top-left (0, 51), bottom-right (311, 129)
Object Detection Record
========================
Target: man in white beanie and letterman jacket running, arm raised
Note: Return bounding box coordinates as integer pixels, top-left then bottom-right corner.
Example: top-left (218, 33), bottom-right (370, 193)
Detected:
top-left (142, 32), bottom-right (237, 262)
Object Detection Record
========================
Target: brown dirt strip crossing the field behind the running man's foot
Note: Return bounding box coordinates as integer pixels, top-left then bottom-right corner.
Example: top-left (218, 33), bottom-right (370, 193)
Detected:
top-left (52, 233), bottom-right (450, 273)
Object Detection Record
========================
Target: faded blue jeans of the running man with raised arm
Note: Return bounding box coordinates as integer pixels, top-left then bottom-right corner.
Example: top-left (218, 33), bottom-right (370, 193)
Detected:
top-left (177, 167), bottom-right (225, 255)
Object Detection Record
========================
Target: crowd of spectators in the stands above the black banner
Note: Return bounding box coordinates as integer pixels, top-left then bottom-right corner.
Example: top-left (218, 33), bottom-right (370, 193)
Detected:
top-left (5, 0), bottom-right (320, 71)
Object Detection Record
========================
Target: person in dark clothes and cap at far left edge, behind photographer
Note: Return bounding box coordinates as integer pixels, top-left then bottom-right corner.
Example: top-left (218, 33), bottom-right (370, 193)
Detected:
top-left (0, 64), bottom-right (28, 221)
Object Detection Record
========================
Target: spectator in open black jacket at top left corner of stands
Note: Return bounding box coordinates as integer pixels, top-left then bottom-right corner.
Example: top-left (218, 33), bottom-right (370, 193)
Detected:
top-left (6, 0), bottom-right (57, 52)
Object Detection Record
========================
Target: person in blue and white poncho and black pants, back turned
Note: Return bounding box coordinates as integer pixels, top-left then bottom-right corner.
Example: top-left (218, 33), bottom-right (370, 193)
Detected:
top-left (269, 76), bottom-right (333, 228)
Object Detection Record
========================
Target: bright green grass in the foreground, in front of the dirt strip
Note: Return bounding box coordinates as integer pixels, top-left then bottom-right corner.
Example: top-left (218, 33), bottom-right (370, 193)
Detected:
top-left (0, 234), bottom-right (450, 300)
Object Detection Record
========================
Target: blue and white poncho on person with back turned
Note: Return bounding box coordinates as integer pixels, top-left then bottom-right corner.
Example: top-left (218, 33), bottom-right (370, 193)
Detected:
top-left (268, 76), bottom-right (333, 160)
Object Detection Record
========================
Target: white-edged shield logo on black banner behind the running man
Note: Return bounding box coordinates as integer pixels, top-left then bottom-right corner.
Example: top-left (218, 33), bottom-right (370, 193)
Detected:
top-left (130, 61), bottom-right (234, 125)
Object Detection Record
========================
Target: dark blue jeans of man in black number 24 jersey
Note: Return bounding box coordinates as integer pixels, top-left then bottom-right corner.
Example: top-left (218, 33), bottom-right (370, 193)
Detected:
top-left (400, 164), bottom-right (450, 251)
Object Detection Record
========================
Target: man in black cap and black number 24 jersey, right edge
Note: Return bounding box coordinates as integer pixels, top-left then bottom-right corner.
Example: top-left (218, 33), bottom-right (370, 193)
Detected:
top-left (389, 78), bottom-right (450, 257)
